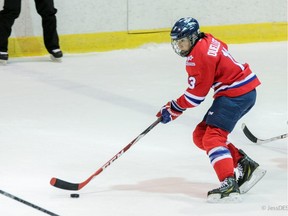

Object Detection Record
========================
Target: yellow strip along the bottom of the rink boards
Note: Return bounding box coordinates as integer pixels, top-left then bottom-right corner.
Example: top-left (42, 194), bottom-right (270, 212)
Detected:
top-left (9, 22), bottom-right (287, 57)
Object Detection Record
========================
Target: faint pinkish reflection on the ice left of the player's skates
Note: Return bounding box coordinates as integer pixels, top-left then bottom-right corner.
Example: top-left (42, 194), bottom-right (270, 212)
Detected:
top-left (112, 177), bottom-right (217, 198)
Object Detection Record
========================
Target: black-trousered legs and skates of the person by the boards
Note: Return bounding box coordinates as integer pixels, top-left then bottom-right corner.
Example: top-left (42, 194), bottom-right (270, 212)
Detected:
top-left (0, 0), bottom-right (63, 64)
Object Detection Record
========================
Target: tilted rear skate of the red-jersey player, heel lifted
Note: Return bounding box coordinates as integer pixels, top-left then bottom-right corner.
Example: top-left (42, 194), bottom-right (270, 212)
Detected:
top-left (237, 149), bottom-right (266, 194)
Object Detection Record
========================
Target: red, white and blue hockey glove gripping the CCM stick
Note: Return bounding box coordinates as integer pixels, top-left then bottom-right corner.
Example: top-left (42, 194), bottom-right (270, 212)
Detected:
top-left (156, 100), bottom-right (186, 124)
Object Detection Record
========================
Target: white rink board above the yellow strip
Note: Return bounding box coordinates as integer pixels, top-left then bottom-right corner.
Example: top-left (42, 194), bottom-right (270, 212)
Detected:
top-left (0, 0), bottom-right (287, 37)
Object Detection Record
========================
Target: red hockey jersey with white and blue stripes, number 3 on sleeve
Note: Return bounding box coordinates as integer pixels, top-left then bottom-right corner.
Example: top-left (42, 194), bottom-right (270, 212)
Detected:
top-left (177, 34), bottom-right (260, 109)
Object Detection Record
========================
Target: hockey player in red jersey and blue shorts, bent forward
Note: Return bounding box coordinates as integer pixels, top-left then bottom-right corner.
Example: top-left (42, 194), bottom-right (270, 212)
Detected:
top-left (157, 17), bottom-right (266, 202)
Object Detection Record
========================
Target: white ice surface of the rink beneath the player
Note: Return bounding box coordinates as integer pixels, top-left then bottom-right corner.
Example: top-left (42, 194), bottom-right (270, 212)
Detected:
top-left (0, 42), bottom-right (288, 216)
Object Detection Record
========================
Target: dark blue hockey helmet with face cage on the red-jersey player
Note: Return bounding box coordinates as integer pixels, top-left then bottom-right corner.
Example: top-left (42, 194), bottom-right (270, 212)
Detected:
top-left (170, 17), bottom-right (200, 57)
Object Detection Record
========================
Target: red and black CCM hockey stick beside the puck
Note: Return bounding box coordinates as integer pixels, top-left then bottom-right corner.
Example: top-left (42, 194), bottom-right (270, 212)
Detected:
top-left (50, 117), bottom-right (162, 190)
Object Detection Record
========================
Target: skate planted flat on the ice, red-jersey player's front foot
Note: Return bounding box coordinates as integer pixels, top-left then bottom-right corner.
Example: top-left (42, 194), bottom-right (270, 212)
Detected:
top-left (207, 177), bottom-right (242, 203)
